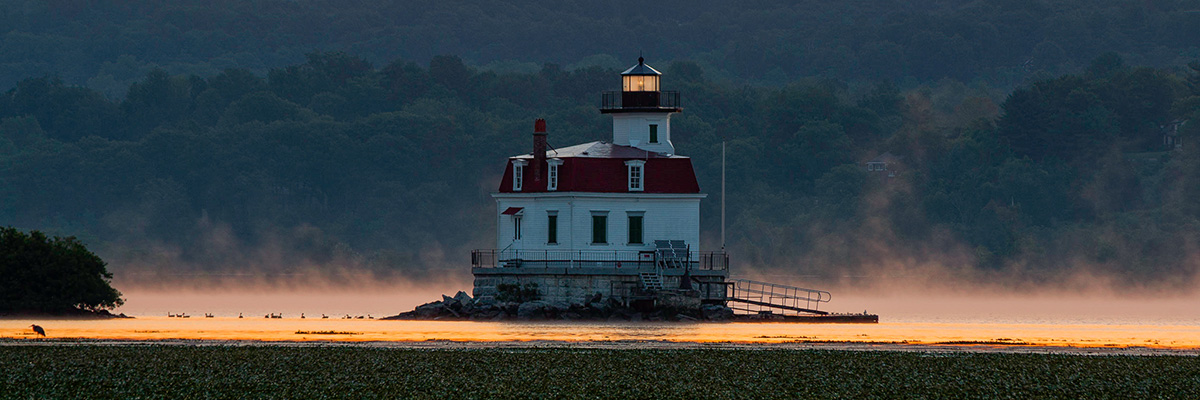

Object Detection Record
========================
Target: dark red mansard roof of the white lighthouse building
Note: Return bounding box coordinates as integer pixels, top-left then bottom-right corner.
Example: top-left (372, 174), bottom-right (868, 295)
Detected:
top-left (499, 142), bottom-right (700, 193)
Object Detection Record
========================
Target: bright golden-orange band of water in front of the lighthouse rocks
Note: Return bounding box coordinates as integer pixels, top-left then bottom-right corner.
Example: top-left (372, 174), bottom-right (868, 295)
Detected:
top-left (0, 317), bottom-right (1200, 348)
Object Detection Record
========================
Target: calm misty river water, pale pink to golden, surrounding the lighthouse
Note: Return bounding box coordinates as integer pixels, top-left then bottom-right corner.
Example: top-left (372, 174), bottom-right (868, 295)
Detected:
top-left (0, 289), bottom-right (1200, 350)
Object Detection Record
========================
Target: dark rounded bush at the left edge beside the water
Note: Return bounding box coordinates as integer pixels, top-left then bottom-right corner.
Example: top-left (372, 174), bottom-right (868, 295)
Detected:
top-left (0, 227), bottom-right (124, 314)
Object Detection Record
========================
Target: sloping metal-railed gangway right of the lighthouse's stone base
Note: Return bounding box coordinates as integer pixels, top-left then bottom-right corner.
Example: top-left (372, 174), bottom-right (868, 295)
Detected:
top-left (726, 279), bottom-right (832, 315)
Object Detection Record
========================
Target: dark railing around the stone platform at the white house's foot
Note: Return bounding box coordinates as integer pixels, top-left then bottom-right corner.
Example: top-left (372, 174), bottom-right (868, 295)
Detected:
top-left (470, 249), bottom-right (730, 270)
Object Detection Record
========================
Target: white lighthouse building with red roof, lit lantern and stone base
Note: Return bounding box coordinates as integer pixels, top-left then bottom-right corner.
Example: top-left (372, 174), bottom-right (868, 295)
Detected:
top-left (472, 58), bottom-right (728, 304)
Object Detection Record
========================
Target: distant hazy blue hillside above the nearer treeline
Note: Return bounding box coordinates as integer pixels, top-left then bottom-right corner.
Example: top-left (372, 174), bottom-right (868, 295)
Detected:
top-left (0, 0), bottom-right (1200, 98)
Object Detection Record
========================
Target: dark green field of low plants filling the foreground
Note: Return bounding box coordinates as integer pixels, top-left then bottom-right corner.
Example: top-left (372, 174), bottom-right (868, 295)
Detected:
top-left (0, 346), bottom-right (1200, 399)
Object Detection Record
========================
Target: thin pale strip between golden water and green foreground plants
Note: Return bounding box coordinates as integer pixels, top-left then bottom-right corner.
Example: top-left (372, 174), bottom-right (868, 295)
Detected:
top-left (0, 338), bottom-right (1200, 357)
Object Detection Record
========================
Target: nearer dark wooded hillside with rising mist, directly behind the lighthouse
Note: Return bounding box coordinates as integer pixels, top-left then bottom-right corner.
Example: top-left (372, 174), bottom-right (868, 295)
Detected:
top-left (0, 52), bottom-right (1200, 286)
